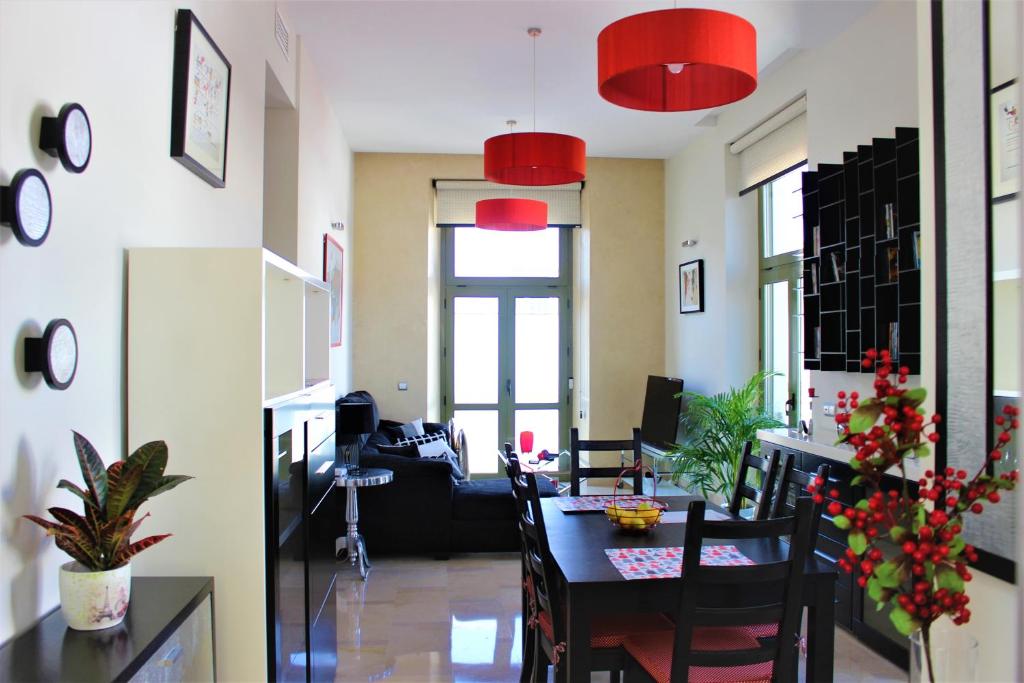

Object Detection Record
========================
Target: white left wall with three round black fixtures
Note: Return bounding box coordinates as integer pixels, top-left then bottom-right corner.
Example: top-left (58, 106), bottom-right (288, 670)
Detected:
top-left (0, 0), bottom-right (351, 642)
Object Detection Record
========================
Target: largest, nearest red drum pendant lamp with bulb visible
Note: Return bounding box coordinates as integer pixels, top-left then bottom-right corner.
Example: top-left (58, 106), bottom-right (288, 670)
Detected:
top-left (597, 9), bottom-right (758, 112)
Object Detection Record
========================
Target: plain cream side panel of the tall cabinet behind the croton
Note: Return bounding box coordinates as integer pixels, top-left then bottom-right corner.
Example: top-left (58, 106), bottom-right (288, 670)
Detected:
top-left (128, 249), bottom-right (266, 681)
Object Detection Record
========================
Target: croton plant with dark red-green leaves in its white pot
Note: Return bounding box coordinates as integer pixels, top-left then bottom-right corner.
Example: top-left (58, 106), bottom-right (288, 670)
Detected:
top-left (25, 432), bottom-right (191, 631)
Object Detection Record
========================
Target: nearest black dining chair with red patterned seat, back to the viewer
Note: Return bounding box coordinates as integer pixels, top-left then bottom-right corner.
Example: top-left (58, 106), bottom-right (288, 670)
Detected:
top-left (625, 498), bottom-right (811, 683)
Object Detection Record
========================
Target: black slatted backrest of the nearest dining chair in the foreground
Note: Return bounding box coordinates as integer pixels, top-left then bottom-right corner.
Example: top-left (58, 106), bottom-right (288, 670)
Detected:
top-left (672, 498), bottom-right (811, 681)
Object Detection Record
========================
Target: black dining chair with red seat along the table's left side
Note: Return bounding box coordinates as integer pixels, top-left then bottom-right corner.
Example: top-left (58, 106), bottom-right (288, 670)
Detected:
top-left (512, 472), bottom-right (673, 681)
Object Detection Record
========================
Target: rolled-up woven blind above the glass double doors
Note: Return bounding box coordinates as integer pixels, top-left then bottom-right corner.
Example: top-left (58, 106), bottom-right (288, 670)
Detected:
top-left (434, 180), bottom-right (583, 227)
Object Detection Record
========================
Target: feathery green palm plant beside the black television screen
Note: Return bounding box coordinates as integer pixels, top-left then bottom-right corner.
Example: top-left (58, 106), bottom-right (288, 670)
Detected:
top-left (669, 371), bottom-right (785, 500)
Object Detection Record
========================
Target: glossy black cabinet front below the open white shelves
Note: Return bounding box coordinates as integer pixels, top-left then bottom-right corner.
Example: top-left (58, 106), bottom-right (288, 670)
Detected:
top-left (264, 387), bottom-right (338, 682)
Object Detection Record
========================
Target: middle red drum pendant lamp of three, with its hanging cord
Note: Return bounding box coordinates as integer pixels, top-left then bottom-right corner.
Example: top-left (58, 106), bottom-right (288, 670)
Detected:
top-left (483, 28), bottom-right (587, 185)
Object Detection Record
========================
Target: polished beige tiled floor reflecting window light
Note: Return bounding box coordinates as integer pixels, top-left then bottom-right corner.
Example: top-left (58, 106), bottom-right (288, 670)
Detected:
top-left (336, 554), bottom-right (906, 683)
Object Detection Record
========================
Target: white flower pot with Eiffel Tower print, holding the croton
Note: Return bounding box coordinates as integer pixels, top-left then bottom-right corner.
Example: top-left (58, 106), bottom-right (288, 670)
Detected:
top-left (60, 562), bottom-right (131, 631)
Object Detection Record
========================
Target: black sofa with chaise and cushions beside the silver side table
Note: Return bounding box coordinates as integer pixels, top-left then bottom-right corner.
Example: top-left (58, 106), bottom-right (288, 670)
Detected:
top-left (338, 391), bottom-right (557, 557)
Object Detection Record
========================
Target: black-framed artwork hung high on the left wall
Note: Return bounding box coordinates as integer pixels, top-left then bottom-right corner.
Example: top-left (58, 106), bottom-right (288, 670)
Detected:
top-left (171, 9), bottom-right (231, 187)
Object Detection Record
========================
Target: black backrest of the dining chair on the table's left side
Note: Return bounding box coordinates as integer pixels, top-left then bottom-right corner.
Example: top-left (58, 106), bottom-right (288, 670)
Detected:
top-left (512, 472), bottom-right (565, 638)
